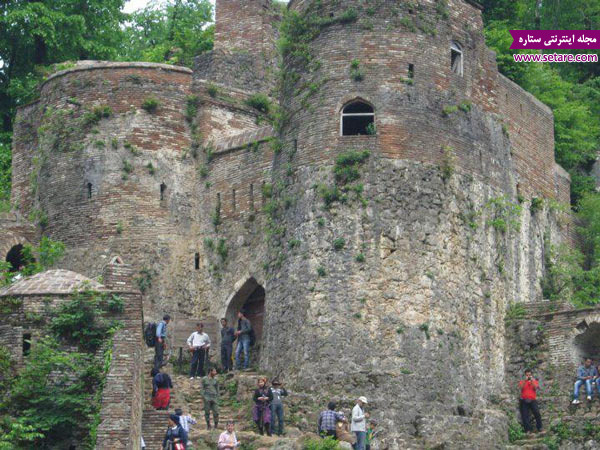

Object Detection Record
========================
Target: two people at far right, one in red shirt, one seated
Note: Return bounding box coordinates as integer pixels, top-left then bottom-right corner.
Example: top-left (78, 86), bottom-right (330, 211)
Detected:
top-left (519, 358), bottom-right (600, 433)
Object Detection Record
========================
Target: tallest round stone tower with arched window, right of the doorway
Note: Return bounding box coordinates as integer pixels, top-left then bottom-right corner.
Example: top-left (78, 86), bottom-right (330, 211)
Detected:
top-left (254, 0), bottom-right (569, 448)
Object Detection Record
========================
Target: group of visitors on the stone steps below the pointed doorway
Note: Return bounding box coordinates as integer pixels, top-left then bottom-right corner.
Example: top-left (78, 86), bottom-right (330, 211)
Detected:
top-left (151, 311), bottom-right (375, 450)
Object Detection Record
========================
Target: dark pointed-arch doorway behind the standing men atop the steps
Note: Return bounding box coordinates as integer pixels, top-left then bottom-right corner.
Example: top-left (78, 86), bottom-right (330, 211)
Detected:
top-left (225, 278), bottom-right (265, 365)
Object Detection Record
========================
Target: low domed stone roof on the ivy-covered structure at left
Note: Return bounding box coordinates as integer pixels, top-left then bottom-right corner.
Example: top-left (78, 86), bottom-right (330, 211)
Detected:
top-left (0, 269), bottom-right (105, 297)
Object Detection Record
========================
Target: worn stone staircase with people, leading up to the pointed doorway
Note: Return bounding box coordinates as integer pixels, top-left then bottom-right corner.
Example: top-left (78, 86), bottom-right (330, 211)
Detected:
top-left (142, 354), bottom-right (317, 450)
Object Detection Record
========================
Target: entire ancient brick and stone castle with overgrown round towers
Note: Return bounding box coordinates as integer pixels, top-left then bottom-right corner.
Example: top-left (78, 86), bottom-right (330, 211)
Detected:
top-left (0, 0), bottom-right (571, 448)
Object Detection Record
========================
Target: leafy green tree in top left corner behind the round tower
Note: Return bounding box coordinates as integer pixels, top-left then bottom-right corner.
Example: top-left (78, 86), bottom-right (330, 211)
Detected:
top-left (0, 0), bottom-right (126, 131)
